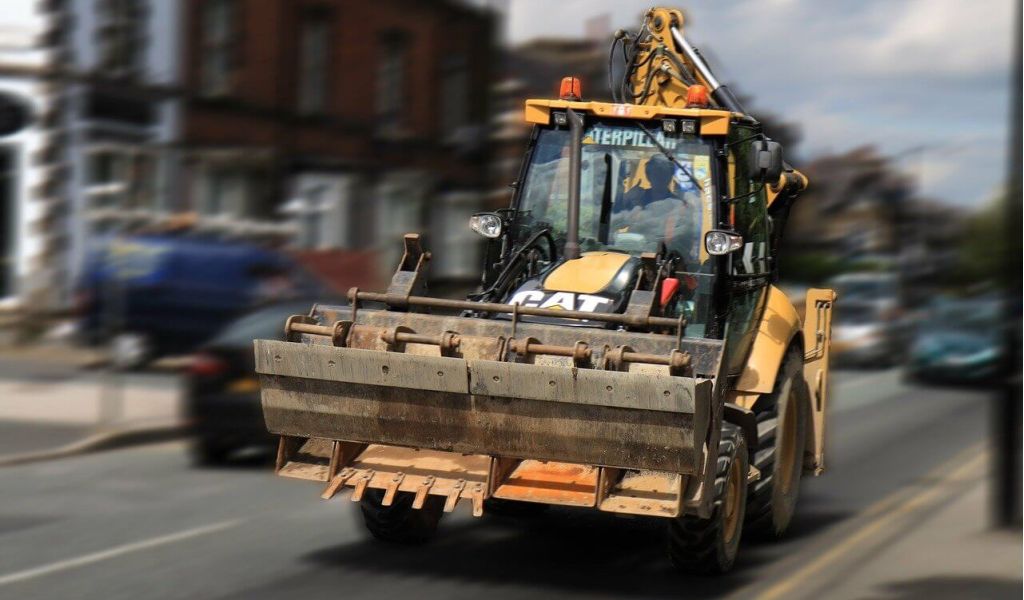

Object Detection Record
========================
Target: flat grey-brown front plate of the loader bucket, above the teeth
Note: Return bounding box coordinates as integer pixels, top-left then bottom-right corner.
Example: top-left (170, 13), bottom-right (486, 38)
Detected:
top-left (256, 341), bottom-right (711, 473)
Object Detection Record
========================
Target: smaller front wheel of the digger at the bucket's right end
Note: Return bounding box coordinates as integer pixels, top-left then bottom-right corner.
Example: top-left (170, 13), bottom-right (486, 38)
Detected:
top-left (669, 423), bottom-right (750, 574)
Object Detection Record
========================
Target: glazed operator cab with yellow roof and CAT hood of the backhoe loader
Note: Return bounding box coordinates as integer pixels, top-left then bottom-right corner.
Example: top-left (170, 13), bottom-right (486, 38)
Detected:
top-left (471, 100), bottom-right (782, 338)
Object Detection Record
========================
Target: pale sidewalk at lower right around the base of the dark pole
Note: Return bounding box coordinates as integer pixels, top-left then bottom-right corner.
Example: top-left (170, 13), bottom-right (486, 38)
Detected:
top-left (754, 451), bottom-right (1024, 600)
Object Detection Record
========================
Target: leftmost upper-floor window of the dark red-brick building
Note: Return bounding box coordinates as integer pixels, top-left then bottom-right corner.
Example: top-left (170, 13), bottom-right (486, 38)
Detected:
top-left (200, 0), bottom-right (239, 96)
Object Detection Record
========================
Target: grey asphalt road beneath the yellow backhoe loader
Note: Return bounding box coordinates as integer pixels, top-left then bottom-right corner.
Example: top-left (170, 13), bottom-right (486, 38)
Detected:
top-left (0, 371), bottom-right (989, 600)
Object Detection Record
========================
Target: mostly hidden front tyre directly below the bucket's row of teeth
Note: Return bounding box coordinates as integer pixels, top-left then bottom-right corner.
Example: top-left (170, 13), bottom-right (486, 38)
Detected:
top-left (359, 489), bottom-right (444, 545)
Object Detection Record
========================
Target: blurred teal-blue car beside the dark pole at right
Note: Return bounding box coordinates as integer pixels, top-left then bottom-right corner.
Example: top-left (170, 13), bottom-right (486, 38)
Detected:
top-left (907, 299), bottom-right (1005, 384)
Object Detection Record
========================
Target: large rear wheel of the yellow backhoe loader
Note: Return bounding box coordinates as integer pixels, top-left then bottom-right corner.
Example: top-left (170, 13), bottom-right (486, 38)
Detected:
top-left (746, 348), bottom-right (809, 540)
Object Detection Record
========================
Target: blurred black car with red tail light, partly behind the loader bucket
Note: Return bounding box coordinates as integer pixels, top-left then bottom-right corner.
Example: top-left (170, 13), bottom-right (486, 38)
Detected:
top-left (185, 298), bottom-right (324, 465)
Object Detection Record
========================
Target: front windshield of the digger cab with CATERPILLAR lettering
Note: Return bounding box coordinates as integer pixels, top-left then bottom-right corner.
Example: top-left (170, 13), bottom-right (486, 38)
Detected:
top-left (518, 120), bottom-right (713, 272)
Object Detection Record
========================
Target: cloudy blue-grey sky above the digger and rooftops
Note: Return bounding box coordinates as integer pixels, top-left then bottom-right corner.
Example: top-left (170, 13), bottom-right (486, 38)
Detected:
top-left (504, 0), bottom-right (1020, 208)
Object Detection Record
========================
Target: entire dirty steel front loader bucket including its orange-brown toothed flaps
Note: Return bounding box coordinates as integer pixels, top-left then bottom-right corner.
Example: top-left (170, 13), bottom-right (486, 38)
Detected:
top-left (255, 307), bottom-right (721, 516)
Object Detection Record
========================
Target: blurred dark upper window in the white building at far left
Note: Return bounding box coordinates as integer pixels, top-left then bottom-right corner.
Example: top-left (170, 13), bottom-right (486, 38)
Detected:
top-left (95, 0), bottom-right (146, 77)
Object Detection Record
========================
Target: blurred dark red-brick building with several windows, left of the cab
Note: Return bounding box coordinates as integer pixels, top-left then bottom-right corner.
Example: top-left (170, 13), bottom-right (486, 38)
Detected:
top-left (182, 0), bottom-right (494, 280)
